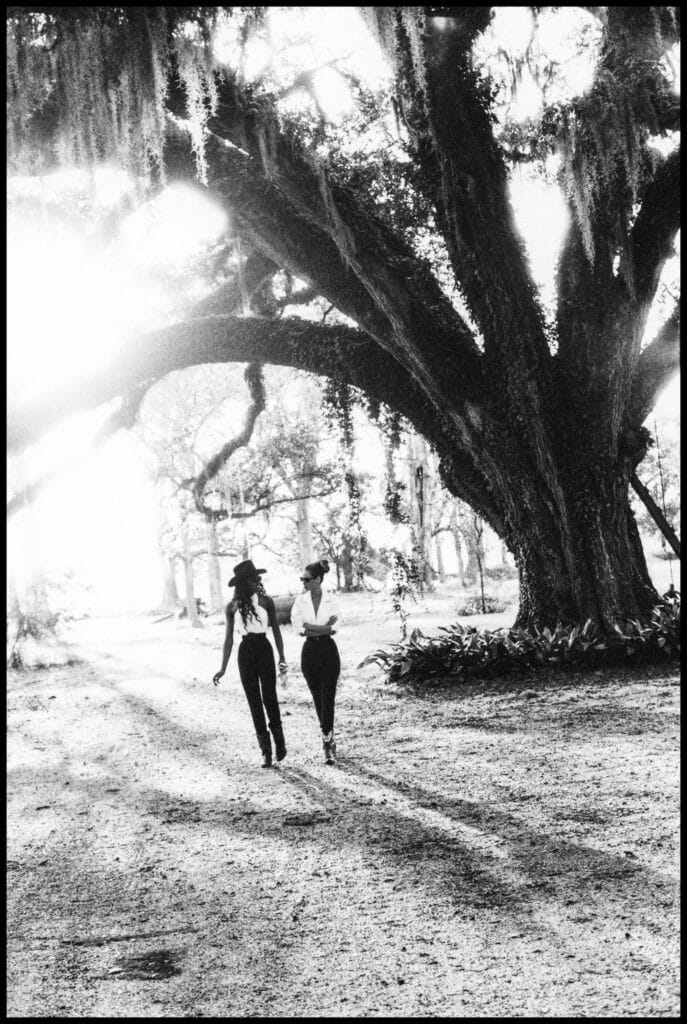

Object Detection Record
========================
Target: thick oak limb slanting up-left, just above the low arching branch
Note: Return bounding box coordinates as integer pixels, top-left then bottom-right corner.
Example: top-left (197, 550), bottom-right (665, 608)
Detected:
top-left (205, 124), bottom-right (480, 408)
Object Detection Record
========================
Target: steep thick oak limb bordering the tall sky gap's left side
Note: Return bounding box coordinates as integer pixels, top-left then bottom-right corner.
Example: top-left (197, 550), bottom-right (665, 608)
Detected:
top-left (367, 7), bottom-right (550, 373)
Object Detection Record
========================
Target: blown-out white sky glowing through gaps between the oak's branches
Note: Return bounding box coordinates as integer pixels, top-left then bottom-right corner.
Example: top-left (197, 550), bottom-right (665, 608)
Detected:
top-left (7, 7), bottom-right (679, 612)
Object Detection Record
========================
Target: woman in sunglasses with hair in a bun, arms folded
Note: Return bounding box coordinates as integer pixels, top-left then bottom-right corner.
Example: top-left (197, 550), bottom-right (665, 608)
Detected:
top-left (291, 559), bottom-right (341, 765)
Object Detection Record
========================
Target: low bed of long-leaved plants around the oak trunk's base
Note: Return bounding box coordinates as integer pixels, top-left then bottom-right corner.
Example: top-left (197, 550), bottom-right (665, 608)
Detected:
top-left (358, 592), bottom-right (680, 683)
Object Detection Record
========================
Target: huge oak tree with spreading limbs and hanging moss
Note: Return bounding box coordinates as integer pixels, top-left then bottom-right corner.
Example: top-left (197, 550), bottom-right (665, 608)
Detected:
top-left (8, 7), bottom-right (680, 628)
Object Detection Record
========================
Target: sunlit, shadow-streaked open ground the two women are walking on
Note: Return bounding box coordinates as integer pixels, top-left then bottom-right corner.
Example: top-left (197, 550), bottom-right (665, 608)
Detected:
top-left (8, 624), bottom-right (680, 1018)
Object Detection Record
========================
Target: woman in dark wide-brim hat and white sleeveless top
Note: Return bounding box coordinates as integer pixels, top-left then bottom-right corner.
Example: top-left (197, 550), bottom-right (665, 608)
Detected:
top-left (212, 558), bottom-right (287, 768)
